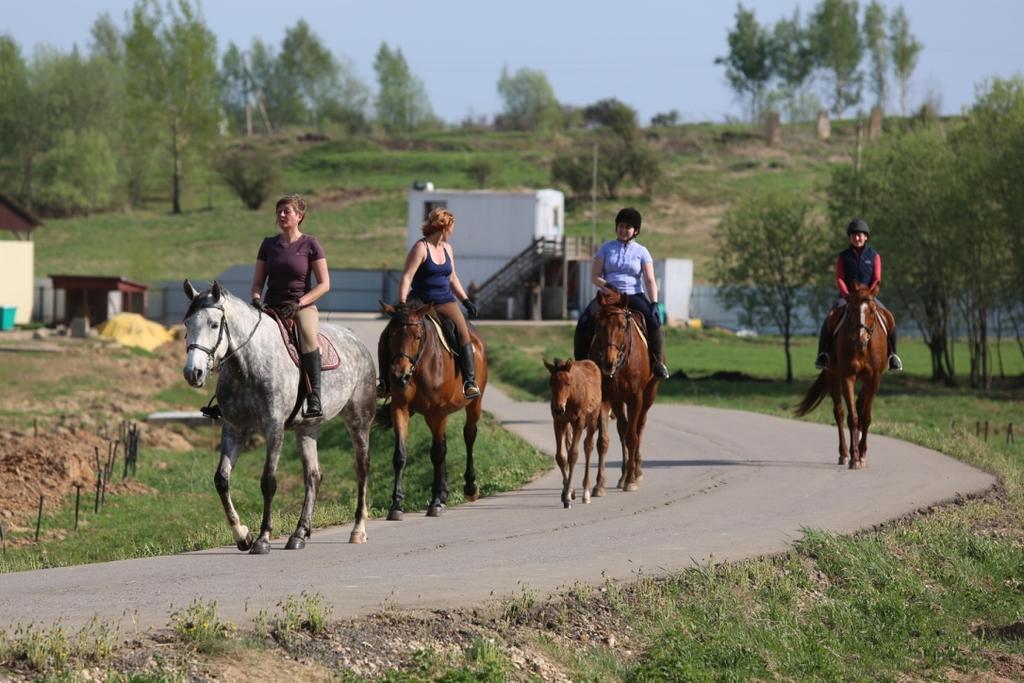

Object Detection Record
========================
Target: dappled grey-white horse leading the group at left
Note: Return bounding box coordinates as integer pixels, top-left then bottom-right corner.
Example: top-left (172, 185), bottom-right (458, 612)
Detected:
top-left (183, 280), bottom-right (377, 555)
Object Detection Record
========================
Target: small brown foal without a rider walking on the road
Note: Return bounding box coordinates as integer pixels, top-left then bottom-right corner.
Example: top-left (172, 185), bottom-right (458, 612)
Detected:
top-left (544, 358), bottom-right (608, 508)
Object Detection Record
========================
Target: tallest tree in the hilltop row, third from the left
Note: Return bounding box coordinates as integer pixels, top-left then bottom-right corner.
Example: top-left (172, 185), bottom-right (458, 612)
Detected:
top-left (810, 0), bottom-right (864, 116)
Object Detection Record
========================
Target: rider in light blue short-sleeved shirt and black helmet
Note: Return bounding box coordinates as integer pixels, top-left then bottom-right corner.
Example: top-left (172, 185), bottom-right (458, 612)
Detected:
top-left (573, 207), bottom-right (669, 379)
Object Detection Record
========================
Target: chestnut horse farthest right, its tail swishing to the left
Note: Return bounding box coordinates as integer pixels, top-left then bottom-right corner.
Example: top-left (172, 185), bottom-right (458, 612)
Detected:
top-left (796, 284), bottom-right (896, 470)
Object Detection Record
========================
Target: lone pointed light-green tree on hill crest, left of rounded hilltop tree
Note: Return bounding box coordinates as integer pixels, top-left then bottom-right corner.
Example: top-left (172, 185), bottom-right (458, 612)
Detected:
top-left (374, 43), bottom-right (434, 133)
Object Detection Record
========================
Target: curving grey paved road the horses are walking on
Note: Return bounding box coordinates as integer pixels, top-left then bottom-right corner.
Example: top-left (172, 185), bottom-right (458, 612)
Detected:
top-left (0, 316), bottom-right (995, 628)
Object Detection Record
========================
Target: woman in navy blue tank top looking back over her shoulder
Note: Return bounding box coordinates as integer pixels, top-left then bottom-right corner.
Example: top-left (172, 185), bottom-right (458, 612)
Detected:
top-left (377, 209), bottom-right (480, 399)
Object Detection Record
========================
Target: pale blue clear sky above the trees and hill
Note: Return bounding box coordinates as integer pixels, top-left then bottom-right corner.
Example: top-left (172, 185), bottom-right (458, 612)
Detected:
top-left (0, 0), bottom-right (1024, 123)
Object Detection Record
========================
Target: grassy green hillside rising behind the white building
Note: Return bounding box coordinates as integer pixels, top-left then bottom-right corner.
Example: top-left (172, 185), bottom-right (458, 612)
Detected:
top-left (19, 122), bottom-right (854, 283)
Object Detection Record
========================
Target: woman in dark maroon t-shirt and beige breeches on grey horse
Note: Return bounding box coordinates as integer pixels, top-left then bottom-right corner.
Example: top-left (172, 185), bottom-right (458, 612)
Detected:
top-left (251, 195), bottom-right (331, 418)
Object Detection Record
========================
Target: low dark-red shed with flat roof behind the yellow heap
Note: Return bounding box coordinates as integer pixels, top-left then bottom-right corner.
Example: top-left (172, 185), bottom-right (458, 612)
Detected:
top-left (50, 275), bottom-right (148, 325)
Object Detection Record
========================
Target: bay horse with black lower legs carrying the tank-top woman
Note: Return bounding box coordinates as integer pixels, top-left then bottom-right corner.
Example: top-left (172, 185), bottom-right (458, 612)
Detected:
top-left (378, 302), bottom-right (487, 521)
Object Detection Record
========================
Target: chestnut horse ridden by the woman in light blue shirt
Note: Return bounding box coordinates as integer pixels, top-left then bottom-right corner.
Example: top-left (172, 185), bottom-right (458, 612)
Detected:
top-left (590, 290), bottom-right (659, 496)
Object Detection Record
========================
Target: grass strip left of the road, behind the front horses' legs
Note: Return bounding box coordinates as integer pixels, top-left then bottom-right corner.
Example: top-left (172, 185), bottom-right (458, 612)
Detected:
top-left (0, 414), bottom-right (551, 572)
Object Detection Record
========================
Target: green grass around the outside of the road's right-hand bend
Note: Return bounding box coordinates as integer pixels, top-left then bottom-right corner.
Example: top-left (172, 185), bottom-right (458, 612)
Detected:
top-left (475, 326), bottom-right (1024, 681)
